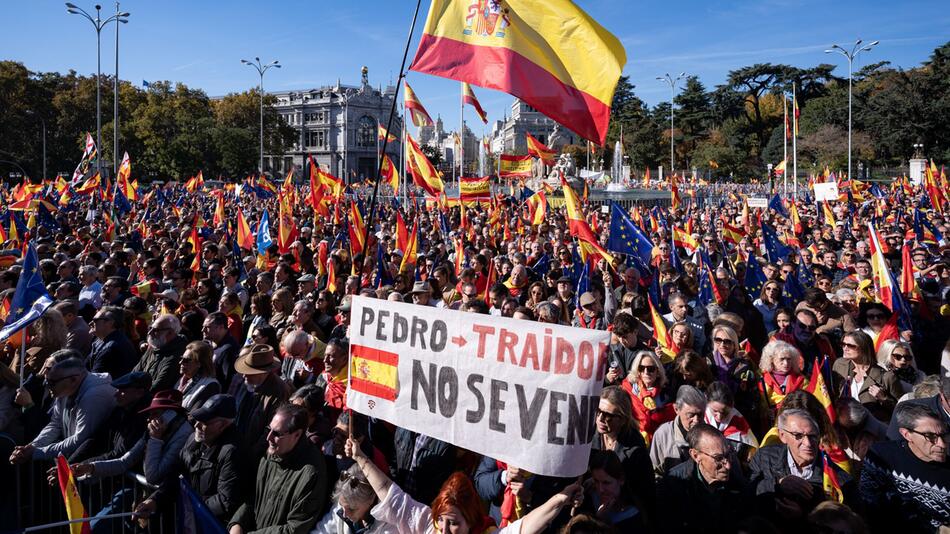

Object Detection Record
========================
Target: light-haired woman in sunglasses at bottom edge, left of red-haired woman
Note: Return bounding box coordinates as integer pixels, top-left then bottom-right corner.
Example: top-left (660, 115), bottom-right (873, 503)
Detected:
top-left (310, 464), bottom-right (399, 534)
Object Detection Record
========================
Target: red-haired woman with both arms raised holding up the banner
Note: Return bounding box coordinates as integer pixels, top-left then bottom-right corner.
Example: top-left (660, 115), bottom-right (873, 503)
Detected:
top-left (346, 438), bottom-right (584, 534)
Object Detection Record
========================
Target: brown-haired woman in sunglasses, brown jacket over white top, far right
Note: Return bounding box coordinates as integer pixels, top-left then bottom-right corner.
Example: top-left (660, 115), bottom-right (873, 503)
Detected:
top-left (831, 331), bottom-right (901, 421)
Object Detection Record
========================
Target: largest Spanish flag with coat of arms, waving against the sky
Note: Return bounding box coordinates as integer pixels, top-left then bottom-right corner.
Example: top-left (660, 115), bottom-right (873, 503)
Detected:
top-left (412, 0), bottom-right (627, 145)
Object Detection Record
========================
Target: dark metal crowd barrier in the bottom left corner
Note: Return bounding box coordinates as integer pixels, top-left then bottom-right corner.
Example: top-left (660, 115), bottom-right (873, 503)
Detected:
top-left (8, 460), bottom-right (178, 534)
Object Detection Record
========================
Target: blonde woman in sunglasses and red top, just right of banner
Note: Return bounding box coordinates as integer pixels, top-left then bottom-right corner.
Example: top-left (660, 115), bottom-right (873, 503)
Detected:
top-left (620, 350), bottom-right (676, 443)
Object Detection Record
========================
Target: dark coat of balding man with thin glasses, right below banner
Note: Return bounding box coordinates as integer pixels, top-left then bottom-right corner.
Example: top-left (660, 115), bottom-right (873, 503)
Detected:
top-left (655, 459), bottom-right (754, 533)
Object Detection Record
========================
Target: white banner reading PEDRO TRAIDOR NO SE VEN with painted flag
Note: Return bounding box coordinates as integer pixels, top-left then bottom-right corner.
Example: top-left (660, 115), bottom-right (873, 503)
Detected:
top-left (346, 296), bottom-right (610, 477)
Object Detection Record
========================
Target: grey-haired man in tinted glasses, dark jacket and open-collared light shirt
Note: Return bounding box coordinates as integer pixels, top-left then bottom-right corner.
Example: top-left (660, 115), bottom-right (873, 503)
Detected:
top-left (749, 408), bottom-right (853, 531)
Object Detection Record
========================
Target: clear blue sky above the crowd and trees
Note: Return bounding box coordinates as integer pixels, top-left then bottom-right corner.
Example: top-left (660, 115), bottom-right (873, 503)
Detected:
top-left (0, 0), bottom-right (950, 138)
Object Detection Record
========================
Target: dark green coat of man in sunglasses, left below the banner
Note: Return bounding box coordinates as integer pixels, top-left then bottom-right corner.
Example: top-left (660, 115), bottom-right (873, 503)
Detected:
top-left (228, 436), bottom-right (330, 534)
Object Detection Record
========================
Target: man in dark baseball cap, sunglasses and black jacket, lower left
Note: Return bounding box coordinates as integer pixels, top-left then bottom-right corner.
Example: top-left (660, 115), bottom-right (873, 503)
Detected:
top-left (135, 394), bottom-right (240, 523)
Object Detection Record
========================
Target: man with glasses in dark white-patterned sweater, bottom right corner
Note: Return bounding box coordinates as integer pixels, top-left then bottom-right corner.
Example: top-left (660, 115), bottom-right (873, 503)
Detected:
top-left (860, 403), bottom-right (950, 532)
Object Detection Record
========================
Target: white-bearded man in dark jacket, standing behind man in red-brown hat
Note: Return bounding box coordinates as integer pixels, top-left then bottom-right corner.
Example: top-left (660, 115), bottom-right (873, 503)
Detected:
top-left (132, 314), bottom-right (188, 393)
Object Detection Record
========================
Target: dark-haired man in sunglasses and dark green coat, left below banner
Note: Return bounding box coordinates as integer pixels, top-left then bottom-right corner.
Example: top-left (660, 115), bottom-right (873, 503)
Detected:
top-left (228, 404), bottom-right (329, 534)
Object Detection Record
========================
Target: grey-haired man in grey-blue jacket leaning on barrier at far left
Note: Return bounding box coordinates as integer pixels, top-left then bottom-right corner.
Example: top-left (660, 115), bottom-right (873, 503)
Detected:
top-left (10, 358), bottom-right (115, 464)
